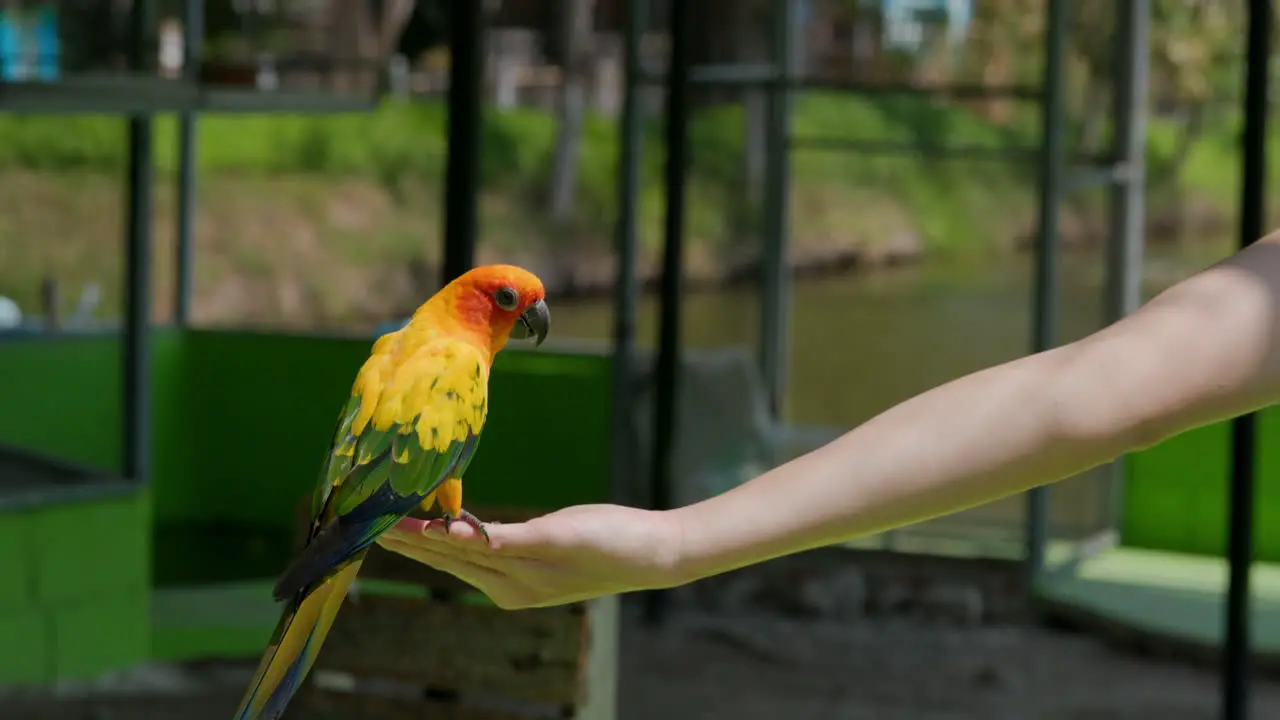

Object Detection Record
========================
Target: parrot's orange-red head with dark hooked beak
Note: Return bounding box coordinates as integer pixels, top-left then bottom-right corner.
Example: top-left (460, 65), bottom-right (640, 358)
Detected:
top-left (438, 265), bottom-right (550, 352)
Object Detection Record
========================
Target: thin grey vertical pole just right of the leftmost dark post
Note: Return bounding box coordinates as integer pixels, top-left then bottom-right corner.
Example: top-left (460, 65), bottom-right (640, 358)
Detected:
top-left (174, 0), bottom-right (205, 325)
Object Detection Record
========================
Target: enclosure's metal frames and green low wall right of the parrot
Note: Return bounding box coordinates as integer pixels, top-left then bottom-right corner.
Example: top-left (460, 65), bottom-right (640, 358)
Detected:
top-left (616, 0), bottom-right (1280, 717)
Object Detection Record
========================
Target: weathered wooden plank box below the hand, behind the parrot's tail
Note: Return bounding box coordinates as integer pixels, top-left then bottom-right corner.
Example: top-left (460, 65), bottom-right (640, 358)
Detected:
top-left (287, 497), bottom-right (618, 720)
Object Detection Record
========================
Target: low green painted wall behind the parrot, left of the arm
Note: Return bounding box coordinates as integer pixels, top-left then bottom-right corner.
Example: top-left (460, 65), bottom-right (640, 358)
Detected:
top-left (0, 331), bottom-right (609, 684)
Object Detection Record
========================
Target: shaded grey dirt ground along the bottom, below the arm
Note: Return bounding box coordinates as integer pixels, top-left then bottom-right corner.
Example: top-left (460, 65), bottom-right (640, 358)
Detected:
top-left (0, 602), bottom-right (1280, 720)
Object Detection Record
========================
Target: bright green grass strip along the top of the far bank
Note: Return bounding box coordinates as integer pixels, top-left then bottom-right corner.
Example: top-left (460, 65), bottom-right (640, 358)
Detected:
top-left (0, 94), bottom-right (1264, 249)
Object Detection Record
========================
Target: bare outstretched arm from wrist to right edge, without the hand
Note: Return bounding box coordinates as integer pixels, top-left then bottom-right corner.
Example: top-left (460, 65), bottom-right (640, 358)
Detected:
top-left (672, 235), bottom-right (1280, 580)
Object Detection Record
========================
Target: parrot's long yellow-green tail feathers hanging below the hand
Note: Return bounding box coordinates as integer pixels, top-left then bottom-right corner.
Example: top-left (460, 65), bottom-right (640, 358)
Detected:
top-left (236, 553), bottom-right (364, 720)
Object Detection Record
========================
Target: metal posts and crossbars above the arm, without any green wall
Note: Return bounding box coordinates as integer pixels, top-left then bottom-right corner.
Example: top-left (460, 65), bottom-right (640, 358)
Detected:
top-left (604, 0), bottom-right (1149, 577)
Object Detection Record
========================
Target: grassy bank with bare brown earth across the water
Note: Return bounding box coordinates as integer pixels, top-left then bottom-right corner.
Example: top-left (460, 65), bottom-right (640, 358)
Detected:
top-left (0, 95), bottom-right (1269, 322)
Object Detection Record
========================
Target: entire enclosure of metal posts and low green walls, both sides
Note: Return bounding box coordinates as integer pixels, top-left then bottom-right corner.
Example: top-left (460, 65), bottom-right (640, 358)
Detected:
top-left (0, 0), bottom-right (1280, 712)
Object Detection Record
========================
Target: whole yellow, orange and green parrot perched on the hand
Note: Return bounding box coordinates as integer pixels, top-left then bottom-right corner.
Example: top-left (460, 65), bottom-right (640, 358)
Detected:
top-left (236, 265), bottom-right (550, 720)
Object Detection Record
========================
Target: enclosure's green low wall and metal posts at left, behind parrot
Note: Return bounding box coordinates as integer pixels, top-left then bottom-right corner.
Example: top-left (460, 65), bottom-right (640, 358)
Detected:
top-left (0, 3), bottom-right (611, 702)
